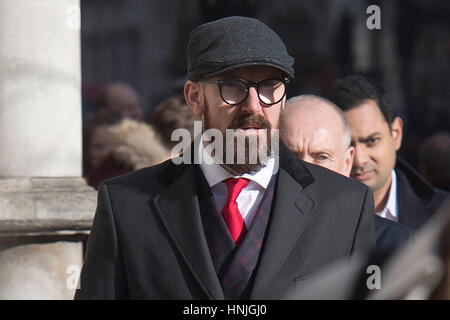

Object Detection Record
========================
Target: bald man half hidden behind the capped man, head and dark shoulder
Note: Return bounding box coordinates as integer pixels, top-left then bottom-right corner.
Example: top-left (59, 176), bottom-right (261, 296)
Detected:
top-left (281, 95), bottom-right (411, 264)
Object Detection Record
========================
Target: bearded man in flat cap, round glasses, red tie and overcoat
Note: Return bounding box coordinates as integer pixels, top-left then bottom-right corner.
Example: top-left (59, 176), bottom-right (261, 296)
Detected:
top-left (76, 17), bottom-right (375, 299)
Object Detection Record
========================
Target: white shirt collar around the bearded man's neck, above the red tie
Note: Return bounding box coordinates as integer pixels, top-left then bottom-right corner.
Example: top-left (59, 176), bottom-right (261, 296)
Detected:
top-left (197, 139), bottom-right (275, 189)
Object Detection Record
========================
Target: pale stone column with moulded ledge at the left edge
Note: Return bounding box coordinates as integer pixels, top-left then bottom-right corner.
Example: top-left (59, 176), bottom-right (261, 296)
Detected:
top-left (0, 0), bottom-right (96, 299)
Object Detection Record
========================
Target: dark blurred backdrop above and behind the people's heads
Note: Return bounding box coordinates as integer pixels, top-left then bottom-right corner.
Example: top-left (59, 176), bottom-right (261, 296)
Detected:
top-left (81, 0), bottom-right (450, 169)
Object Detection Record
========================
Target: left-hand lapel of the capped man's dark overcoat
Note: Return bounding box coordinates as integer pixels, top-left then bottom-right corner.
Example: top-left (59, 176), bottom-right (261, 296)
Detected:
top-left (153, 156), bottom-right (224, 299)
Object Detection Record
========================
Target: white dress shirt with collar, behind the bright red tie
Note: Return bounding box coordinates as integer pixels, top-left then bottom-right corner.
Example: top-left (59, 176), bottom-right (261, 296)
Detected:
top-left (198, 141), bottom-right (275, 229)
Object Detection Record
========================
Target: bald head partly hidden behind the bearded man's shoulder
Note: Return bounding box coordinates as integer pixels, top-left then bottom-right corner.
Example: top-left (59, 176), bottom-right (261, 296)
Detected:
top-left (281, 95), bottom-right (354, 176)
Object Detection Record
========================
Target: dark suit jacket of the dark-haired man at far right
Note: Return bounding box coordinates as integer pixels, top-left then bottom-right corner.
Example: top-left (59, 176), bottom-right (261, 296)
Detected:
top-left (395, 157), bottom-right (449, 231)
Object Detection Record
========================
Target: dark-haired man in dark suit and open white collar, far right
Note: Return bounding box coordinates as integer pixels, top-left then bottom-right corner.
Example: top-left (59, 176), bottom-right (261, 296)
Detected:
top-left (326, 75), bottom-right (448, 231)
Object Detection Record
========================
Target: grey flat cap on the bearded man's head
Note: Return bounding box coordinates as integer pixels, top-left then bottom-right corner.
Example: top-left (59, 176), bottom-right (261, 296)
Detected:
top-left (186, 17), bottom-right (294, 81)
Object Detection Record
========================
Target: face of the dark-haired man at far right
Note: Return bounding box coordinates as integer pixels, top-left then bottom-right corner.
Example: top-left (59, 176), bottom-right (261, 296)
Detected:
top-left (345, 100), bottom-right (402, 193)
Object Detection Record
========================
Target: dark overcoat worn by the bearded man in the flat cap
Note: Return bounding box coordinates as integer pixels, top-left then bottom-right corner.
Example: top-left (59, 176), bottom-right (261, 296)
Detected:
top-left (75, 143), bottom-right (375, 299)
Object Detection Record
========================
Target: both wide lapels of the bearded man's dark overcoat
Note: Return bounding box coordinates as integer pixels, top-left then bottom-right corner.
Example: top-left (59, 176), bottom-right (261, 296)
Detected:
top-left (152, 141), bottom-right (314, 299)
